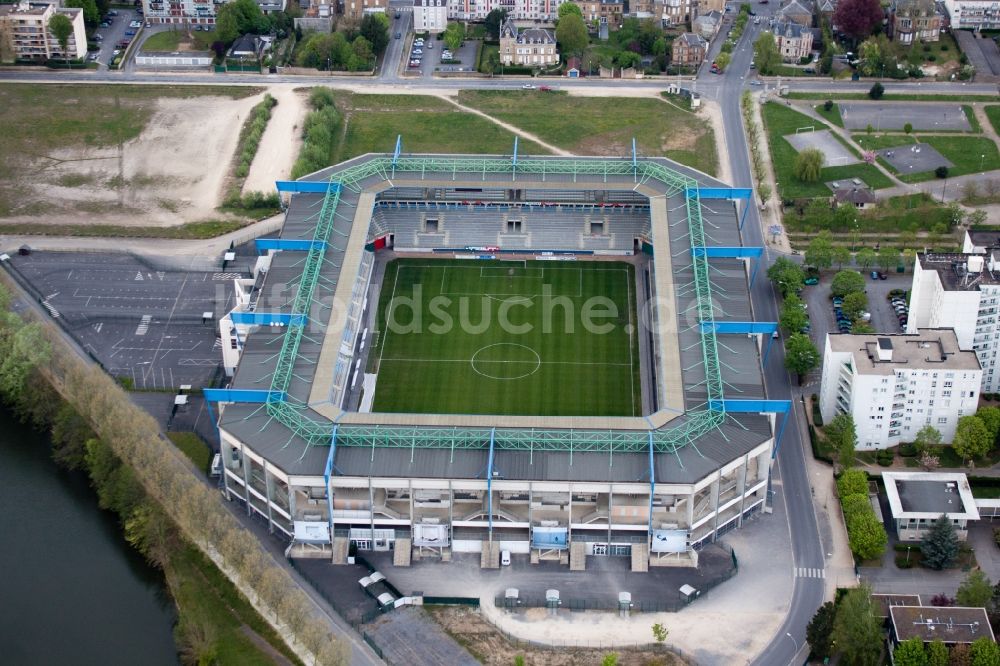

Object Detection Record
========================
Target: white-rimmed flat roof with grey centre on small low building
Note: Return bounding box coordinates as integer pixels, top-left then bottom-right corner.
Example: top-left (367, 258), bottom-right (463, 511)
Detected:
top-left (882, 472), bottom-right (979, 520)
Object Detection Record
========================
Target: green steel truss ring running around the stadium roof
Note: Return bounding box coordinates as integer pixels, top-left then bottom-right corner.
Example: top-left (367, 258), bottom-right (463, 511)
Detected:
top-left (266, 155), bottom-right (725, 453)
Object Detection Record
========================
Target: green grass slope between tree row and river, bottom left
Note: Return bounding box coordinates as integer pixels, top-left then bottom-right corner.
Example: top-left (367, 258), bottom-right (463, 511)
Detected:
top-left (165, 545), bottom-right (300, 666)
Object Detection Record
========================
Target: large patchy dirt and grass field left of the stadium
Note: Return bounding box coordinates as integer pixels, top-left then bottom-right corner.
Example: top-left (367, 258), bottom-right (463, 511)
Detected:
top-left (0, 86), bottom-right (261, 227)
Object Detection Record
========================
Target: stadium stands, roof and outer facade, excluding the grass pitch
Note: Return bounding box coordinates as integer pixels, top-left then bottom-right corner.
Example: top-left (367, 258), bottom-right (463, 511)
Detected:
top-left (215, 151), bottom-right (777, 571)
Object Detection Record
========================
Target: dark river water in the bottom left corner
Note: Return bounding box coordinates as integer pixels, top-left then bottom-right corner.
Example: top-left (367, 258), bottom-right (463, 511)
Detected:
top-left (0, 407), bottom-right (178, 666)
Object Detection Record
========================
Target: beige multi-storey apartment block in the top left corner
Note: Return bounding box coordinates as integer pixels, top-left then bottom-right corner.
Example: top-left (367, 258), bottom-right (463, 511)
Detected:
top-left (0, 2), bottom-right (87, 62)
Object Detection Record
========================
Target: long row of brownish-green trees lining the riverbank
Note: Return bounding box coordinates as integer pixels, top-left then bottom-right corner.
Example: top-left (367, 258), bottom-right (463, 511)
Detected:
top-left (0, 278), bottom-right (348, 665)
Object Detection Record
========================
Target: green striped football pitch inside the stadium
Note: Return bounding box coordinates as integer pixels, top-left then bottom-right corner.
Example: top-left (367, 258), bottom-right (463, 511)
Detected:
top-left (368, 259), bottom-right (642, 416)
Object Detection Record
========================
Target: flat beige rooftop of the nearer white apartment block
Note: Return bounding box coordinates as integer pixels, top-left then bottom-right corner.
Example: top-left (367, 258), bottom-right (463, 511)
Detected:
top-left (829, 328), bottom-right (982, 375)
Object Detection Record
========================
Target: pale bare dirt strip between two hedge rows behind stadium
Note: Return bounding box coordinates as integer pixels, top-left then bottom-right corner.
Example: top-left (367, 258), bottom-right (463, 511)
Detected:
top-left (243, 88), bottom-right (307, 193)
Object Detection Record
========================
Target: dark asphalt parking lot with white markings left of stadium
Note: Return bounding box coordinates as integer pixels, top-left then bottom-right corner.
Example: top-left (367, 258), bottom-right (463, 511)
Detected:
top-left (3, 251), bottom-right (244, 389)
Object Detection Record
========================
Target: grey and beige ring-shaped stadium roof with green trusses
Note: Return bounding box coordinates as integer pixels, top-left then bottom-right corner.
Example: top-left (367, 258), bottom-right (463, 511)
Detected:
top-left (220, 155), bottom-right (770, 482)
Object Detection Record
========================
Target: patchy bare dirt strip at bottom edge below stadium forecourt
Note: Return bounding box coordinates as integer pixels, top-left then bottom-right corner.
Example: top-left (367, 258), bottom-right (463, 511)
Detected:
top-left (426, 606), bottom-right (688, 666)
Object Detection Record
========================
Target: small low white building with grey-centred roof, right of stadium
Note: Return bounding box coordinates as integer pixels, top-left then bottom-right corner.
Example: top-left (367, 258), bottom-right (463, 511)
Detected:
top-left (882, 472), bottom-right (979, 541)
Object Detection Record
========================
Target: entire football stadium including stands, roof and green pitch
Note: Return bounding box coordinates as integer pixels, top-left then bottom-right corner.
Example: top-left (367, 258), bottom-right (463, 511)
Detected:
top-left (206, 149), bottom-right (781, 571)
